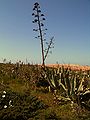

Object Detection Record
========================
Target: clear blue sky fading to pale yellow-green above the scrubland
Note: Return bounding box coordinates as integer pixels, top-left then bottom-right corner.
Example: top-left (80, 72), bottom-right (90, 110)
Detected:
top-left (0, 0), bottom-right (90, 65)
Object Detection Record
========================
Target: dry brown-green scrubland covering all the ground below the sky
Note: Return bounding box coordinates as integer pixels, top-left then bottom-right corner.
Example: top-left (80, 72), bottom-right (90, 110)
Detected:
top-left (0, 62), bottom-right (90, 120)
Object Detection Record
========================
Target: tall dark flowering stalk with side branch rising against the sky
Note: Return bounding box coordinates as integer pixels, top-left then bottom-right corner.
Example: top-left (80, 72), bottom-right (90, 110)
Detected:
top-left (32, 2), bottom-right (54, 66)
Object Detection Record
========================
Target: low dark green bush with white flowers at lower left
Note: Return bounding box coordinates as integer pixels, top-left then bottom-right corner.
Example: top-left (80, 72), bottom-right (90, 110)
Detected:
top-left (0, 91), bottom-right (44, 120)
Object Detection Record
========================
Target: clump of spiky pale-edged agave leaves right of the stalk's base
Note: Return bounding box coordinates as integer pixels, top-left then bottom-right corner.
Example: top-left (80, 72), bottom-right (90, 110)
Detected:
top-left (41, 66), bottom-right (90, 109)
